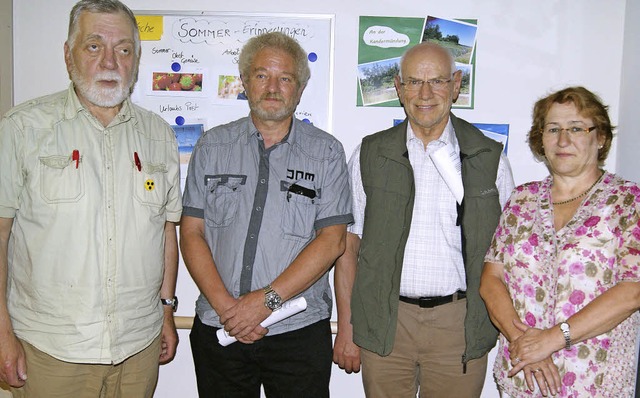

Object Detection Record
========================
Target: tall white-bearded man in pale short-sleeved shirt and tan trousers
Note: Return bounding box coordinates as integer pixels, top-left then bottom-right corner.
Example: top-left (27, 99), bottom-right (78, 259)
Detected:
top-left (0, 0), bottom-right (182, 398)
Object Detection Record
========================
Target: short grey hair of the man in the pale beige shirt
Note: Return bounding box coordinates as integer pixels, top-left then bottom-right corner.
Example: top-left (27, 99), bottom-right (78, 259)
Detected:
top-left (67, 0), bottom-right (140, 58)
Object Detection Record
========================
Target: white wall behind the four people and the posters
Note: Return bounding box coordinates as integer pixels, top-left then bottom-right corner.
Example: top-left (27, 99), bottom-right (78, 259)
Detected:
top-left (14, 0), bottom-right (640, 398)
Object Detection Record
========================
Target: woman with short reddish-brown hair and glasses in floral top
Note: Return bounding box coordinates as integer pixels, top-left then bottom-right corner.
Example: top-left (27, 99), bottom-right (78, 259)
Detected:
top-left (480, 87), bottom-right (640, 398)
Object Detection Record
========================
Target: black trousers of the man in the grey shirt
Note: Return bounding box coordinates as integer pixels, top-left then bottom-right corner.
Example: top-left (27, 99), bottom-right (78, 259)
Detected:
top-left (189, 316), bottom-right (333, 398)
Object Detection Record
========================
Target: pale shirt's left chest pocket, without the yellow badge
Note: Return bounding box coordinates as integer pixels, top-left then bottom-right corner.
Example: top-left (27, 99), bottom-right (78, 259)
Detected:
top-left (39, 155), bottom-right (85, 204)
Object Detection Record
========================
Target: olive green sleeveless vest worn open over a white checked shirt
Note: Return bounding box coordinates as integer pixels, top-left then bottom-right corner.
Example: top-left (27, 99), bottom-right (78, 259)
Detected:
top-left (351, 114), bottom-right (502, 363)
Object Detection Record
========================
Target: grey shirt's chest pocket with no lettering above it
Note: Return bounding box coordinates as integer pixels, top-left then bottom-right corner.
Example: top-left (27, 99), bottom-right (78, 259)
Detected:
top-left (204, 174), bottom-right (247, 228)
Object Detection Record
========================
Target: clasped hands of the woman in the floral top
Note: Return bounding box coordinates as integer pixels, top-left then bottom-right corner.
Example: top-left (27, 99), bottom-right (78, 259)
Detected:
top-left (508, 320), bottom-right (561, 397)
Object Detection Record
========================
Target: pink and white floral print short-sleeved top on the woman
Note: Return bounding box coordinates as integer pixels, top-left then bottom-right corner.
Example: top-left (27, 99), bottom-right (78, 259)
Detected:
top-left (485, 173), bottom-right (640, 398)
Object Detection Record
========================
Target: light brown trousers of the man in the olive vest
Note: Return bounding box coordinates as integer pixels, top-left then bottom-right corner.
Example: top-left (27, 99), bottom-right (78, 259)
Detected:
top-left (361, 299), bottom-right (487, 398)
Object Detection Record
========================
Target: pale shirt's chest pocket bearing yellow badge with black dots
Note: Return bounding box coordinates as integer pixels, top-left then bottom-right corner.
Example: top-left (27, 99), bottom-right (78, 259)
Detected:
top-left (132, 162), bottom-right (167, 207)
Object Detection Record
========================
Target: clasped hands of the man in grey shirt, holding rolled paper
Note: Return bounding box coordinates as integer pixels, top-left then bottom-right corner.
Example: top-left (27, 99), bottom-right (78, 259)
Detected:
top-left (220, 289), bottom-right (271, 344)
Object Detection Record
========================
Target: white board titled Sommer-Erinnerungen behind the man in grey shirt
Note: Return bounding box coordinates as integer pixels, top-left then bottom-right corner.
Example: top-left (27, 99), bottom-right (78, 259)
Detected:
top-left (132, 11), bottom-right (334, 154)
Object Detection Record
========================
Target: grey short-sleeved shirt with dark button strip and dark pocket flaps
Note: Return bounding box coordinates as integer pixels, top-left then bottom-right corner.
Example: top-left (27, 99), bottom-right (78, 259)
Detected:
top-left (183, 117), bottom-right (353, 335)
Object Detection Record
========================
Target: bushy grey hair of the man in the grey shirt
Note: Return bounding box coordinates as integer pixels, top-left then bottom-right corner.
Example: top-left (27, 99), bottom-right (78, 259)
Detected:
top-left (238, 32), bottom-right (311, 87)
